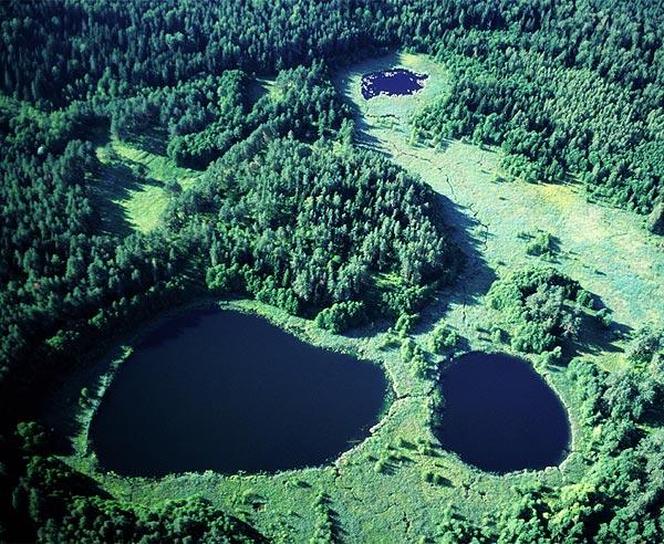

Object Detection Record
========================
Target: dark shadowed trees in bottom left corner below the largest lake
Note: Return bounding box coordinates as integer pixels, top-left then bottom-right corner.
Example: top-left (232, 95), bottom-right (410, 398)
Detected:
top-left (13, 457), bottom-right (262, 544)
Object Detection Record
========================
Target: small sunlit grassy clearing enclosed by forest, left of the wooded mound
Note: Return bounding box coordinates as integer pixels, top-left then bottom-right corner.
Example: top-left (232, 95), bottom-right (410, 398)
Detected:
top-left (96, 135), bottom-right (200, 234)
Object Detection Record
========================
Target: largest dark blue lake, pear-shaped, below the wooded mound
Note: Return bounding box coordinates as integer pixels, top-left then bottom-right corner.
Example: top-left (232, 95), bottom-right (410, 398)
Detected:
top-left (90, 309), bottom-right (387, 476)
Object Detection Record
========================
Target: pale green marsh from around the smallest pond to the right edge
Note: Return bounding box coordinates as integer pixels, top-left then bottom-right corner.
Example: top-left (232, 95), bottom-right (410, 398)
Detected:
top-left (339, 51), bottom-right (664, 368)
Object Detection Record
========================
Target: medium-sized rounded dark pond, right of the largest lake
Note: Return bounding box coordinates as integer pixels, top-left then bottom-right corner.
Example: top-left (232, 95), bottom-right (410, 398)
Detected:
top-left (436, 352), bottom-right (570, 473)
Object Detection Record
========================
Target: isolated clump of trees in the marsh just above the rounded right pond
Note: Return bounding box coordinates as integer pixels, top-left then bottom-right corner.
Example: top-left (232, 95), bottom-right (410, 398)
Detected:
top-left (488, 267), bottom-right (580, 353)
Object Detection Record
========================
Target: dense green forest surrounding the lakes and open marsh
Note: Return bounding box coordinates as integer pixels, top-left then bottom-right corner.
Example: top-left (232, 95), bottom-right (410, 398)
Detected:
top-left (0, 0), bottom-right (664, 544)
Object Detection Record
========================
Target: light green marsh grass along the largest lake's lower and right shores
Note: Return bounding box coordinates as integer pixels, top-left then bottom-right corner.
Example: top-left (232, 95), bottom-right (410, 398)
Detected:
top-left (54, 301), bottom-right (548, 542)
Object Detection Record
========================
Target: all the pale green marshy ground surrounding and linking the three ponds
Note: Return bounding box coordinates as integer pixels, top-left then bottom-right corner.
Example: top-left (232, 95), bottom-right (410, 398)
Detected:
top-left (54, 55), bottom-right (664, 543)
